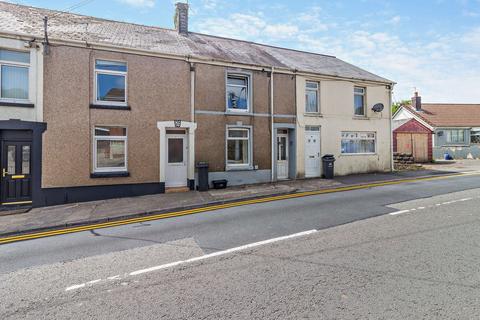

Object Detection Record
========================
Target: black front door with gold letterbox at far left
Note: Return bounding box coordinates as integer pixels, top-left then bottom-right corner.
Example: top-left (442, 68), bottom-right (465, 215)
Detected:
top-left (0, 141), bottom-right (32, 205)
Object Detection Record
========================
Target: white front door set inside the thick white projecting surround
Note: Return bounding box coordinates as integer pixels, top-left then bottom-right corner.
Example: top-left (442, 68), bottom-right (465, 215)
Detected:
top-left (165, 134), bottom-right (188, 188)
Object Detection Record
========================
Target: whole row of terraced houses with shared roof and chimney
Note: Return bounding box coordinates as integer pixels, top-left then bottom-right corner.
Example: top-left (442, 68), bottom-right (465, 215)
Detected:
top-left (0, 2), bottom-right (393, 207)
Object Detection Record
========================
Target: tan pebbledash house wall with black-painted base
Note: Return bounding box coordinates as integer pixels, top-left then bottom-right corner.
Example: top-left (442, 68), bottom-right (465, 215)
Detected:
top-left (42, 46), bottom-right (191, 205)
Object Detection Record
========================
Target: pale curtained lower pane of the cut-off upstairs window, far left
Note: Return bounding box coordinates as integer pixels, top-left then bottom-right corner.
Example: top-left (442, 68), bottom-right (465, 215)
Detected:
top-left (1, 65), bottom-right (28, 99)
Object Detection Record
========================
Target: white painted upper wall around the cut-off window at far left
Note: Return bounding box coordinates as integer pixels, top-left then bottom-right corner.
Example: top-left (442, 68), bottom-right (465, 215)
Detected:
top-left (0, 37), bottom-right (43, 122)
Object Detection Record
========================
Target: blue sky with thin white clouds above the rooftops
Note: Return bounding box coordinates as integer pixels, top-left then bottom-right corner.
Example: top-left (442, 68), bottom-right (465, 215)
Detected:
top-left (11, 0), bottom-right (480, 103)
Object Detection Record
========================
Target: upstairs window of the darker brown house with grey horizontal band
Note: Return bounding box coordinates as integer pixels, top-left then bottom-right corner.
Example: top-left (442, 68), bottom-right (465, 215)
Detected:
top-left (227, 73), bottom-right (250, 112)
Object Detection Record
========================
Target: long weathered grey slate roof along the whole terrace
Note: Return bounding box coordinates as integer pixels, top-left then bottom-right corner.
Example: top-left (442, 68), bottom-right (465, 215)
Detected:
top-left (0, 2), bottom-right (392, 83)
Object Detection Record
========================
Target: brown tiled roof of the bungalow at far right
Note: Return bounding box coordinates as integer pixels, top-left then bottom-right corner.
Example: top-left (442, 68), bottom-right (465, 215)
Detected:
top-left (406, 103), bottom-right (480, 128)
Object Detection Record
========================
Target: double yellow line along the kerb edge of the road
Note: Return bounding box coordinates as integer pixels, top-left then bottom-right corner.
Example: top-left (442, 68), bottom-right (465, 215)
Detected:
top-left (0, 173), bottom-right (479, 244)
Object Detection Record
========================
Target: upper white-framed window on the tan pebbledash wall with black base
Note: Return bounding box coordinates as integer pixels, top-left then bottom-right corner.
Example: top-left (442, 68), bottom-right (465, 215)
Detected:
top-left (94, 60), bottom-right (128, 106)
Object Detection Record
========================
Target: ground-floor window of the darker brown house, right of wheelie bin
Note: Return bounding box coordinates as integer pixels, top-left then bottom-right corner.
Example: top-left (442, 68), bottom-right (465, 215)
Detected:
top-left (226, 127), bottom-right (252, 169)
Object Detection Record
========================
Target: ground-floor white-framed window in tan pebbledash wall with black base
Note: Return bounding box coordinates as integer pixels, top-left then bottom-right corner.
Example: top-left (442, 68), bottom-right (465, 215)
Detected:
top-left (93, 126), bottom-right (127, 173)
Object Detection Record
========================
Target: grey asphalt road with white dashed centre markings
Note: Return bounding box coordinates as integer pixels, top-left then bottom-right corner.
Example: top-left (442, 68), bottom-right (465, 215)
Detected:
top-left (0, 176), bottom-right (480, 319)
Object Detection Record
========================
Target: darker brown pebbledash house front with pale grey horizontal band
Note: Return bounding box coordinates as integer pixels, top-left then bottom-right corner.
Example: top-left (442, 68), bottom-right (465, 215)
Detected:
top-left (195, 64), bottom-right (295, 185)
